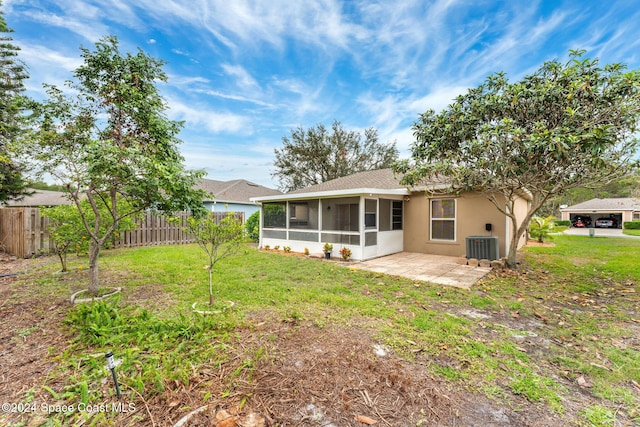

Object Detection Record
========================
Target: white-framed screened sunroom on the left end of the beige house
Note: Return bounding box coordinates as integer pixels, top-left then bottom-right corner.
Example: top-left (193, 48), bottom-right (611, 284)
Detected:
top-left (258, 189), bottom-right (406, 260)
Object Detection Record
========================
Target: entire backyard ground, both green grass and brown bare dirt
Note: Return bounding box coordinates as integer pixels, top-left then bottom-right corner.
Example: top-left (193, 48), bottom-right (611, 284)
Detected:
top-left (0, 236), bottom-right (640, 426)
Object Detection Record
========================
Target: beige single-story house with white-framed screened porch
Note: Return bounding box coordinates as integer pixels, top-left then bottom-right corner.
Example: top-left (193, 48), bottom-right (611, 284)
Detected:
top-left (252, 169), bottom-right (529, 260)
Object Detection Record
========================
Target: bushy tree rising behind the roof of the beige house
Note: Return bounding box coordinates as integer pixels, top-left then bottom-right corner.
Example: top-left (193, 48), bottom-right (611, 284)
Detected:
top-left (272, 121), bottom-right (398, 191)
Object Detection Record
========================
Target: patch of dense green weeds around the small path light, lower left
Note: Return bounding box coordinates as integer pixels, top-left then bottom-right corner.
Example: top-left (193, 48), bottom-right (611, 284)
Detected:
top-left (43, 297), bottom-right (237, 426)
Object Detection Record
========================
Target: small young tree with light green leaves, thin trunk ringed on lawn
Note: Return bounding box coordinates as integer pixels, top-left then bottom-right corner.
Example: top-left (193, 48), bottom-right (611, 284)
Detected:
top-left (188, 212), bottom-right (244, 306)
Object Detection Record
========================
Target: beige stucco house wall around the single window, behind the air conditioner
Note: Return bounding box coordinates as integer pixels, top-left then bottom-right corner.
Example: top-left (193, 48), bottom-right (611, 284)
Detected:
top-left (404, 192), bottom-right (527, 257)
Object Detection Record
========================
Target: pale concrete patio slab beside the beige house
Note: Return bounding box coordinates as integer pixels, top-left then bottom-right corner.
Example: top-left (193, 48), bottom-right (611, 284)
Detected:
top-left (351, 252), bottom-right (491, 289)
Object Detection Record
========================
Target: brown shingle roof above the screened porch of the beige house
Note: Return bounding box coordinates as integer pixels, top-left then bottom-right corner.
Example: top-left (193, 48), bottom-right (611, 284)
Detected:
top-left (287, 169), bottom-right (405, 194)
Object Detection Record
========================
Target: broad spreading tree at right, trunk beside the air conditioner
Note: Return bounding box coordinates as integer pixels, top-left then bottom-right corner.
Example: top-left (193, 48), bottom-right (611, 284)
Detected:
top-left (396, 51), bottom-right (640, 267)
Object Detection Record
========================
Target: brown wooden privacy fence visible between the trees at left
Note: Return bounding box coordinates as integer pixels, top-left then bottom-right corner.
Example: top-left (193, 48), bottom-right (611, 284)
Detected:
top-left (0, 208), bottom-right (244, 258)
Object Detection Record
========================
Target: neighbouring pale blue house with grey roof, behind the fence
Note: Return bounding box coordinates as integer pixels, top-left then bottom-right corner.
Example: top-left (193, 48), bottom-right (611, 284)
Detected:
top-left (196, 179), bottom-right (282, 220)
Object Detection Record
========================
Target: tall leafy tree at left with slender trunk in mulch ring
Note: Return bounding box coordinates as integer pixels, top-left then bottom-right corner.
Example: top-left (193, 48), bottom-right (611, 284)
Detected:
top-left (27, 36), bottom-right (204, 294)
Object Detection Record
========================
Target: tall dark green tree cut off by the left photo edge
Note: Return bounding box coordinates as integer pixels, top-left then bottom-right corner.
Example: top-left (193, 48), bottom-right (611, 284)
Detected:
top-left (0, 2), bottom-right (29, 204)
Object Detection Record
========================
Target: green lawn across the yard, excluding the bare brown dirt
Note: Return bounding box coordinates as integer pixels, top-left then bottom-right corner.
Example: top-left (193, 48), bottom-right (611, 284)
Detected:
top-left (5, 236), bottom-right (640, 426)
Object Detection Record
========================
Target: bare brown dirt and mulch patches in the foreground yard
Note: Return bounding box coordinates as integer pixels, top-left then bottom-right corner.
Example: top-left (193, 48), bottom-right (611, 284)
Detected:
top-left (0, 257), bottom-right (632, 427)
